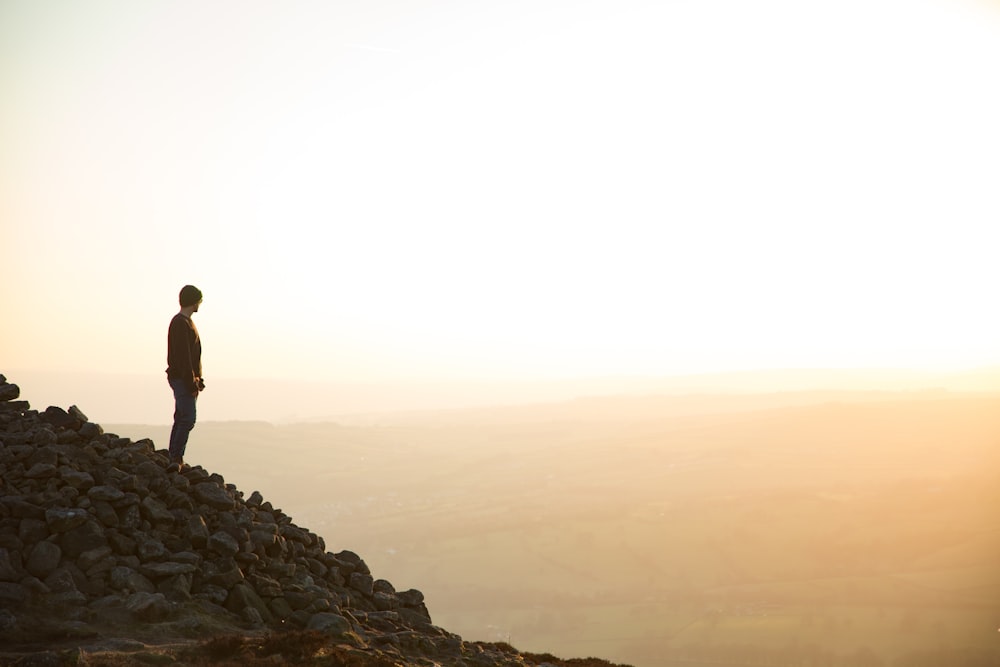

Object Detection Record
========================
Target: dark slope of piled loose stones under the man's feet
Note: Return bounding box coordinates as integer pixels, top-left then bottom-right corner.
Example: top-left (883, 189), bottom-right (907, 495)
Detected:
top-left (0, 375), bottom-right (632, 667)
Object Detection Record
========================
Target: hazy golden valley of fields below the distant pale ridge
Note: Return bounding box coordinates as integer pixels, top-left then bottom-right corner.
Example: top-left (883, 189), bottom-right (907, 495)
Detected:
top-left (105, 392), bottom-right (1000, 667)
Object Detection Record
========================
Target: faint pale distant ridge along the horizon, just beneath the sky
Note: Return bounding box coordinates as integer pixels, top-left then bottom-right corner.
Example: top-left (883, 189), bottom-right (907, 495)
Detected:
top-left (7, 368), bottom-right (1000, 424)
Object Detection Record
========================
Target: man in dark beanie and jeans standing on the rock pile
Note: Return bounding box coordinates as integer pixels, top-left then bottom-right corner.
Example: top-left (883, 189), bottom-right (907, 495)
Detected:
top-left (167, 285), bottom-right (205, 471)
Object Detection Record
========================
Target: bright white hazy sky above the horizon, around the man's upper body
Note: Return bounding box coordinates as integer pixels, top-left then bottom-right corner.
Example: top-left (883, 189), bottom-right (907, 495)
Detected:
top-left (0, 0), bottom-right (1000, 380)
